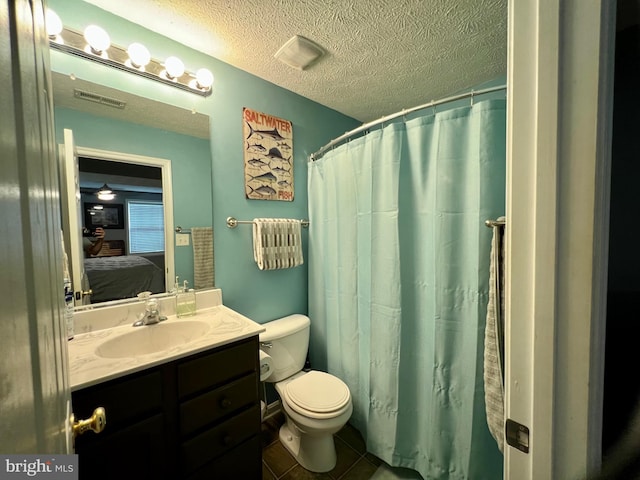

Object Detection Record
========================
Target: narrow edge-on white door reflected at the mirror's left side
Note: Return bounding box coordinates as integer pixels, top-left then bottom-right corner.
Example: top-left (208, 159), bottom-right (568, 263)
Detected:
top-left (60, 128), bottom-right (90, 305)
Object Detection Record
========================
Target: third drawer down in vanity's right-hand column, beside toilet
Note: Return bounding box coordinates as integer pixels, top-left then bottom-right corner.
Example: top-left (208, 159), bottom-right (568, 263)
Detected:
top-left (180, 405), bottom-right (260, 474)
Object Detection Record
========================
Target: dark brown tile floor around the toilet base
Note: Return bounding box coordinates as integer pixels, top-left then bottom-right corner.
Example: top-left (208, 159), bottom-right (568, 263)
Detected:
top-left (262, 413), bottom-right (383, 480)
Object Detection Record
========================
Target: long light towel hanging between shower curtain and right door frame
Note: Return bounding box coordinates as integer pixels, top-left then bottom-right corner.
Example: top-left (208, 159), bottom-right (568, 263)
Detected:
top-left (484, 218), bottom-right (504, 452)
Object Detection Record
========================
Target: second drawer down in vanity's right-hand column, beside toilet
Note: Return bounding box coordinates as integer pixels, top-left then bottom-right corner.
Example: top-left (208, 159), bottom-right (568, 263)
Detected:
top-left (180, 373), bottom-right (258, 435)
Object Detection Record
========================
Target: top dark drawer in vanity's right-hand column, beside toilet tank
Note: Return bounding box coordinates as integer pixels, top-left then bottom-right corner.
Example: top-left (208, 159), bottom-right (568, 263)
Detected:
top-left (178, 336), bottom-right (258, 398)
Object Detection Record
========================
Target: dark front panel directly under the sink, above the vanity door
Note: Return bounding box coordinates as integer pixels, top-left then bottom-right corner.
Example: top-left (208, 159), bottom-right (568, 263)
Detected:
top-left (71, 370), bottom-right (163, 433)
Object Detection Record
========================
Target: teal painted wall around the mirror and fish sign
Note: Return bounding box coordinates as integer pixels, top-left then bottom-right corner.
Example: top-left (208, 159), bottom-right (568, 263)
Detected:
top-left (48, 0), bottom-right (360, 323)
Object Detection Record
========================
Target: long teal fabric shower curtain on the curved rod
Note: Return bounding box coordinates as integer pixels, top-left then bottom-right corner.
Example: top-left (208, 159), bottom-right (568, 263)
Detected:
top-left (308, 100), bottom-right (506, 480)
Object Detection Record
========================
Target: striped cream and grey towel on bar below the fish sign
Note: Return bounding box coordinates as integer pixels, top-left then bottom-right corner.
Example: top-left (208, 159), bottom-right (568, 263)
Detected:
top-left (253, 218), bottom-right (304, 270)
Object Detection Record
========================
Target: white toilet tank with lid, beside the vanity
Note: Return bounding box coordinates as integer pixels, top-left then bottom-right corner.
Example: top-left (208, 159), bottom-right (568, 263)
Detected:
top-left (260, 314), bottom-right (311, 383)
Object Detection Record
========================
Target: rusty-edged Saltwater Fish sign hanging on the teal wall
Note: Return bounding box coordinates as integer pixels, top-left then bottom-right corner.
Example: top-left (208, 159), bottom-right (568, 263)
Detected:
top-left (242, 107), bottom-right (293, 202)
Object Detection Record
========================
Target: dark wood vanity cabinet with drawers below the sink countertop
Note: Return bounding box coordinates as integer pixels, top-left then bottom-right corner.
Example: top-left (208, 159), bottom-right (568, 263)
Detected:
top-left (72, 336), bottom-right (262, 480)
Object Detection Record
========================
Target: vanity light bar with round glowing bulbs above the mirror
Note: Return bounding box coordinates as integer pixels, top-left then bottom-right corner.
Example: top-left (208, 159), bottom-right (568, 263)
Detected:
top-left (49, 27), bottom-right (213, 97)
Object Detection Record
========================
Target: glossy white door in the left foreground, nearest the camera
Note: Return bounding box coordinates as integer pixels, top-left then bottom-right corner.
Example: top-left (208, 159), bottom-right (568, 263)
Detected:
top-left (0, 0), bottom-right (71, 454)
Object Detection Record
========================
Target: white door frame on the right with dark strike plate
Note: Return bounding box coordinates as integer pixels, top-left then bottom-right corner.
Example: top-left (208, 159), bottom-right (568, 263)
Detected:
top-left (504, 0), bottom-right (615, 480)
